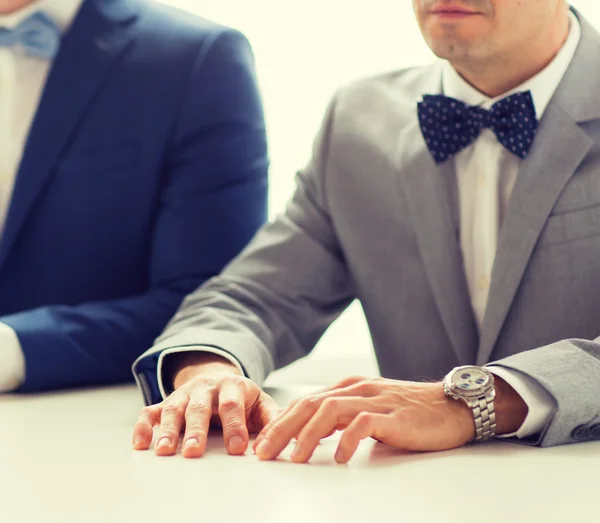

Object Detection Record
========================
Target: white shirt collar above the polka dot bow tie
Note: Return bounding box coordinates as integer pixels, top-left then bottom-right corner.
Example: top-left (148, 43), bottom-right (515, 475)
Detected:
top-left (442, 11), bottom-right (581, 120)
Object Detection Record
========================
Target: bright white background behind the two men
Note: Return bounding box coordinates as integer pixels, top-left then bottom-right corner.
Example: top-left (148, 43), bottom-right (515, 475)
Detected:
top-left (157, 0), bottom-right (600, 368)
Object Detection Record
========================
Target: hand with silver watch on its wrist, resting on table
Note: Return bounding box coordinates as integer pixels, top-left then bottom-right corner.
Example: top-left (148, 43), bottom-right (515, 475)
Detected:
top-left (254, 377), bottom-right (475, 463)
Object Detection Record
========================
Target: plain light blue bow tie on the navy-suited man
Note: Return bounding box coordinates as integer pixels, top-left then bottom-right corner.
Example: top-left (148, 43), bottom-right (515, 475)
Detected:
top-left (0, 12), bottom-right (61, 60)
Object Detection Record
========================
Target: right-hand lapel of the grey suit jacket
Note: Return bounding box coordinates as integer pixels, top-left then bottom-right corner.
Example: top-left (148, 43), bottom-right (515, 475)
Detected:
top-left (477, 12), bottom-right (600, 365)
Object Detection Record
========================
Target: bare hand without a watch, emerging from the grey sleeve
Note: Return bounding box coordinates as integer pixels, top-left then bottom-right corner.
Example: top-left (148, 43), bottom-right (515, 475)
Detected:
top-left (133, 355), bottom-right (279, 458)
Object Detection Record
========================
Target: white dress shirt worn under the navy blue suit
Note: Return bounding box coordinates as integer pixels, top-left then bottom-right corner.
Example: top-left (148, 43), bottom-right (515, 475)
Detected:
top-left (0, 0), bottom-right (83, 392)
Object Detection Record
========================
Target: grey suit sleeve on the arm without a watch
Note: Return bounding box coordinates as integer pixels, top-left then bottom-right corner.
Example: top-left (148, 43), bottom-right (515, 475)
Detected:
top-left (134, 93), bottom-right (355, 403)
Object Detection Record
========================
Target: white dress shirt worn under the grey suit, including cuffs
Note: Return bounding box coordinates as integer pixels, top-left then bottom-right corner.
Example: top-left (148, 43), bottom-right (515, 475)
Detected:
top-left (158, 12), bottom-right (581, 438)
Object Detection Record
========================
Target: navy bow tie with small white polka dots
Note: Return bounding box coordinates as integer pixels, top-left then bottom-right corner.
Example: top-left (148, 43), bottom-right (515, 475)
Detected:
top-left (418, 91), bottom-right (538, 164)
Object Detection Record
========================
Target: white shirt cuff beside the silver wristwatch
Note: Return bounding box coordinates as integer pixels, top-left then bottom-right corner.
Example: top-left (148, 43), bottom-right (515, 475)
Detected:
top-left (487, 366), bottom-right (556, 439)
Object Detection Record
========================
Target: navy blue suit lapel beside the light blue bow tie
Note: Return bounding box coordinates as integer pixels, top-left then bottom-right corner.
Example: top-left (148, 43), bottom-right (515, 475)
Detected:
top-left (0, 0), bottom-right (136, 268)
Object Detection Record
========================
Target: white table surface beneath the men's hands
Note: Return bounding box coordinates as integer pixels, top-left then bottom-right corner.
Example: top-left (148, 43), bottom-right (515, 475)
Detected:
top-left (0, 357), bottom-right (600, 523)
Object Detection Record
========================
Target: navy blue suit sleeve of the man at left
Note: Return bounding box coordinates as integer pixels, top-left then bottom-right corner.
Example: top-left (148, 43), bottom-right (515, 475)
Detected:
top-left (0, 30), bottom-right (268, 392)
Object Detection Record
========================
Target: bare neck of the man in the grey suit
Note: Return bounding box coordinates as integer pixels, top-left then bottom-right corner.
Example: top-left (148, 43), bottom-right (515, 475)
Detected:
top-left (452, 10), bottom-right (569, 98)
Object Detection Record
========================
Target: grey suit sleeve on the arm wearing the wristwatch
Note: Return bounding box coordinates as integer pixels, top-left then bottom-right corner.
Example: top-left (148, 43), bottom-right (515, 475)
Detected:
top-left (492, 338), bottom-right (600, 447)
